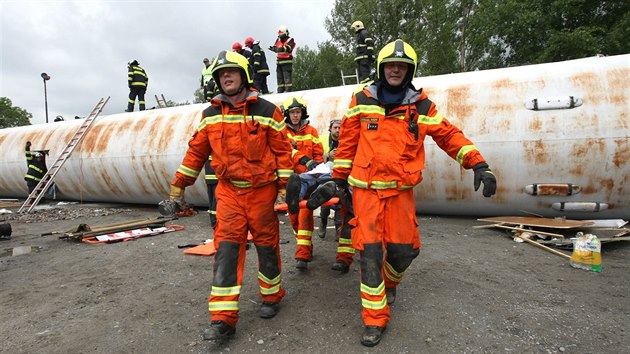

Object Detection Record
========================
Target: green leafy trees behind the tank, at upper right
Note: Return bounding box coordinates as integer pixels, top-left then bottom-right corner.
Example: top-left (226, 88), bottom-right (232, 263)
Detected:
top-left (293, 0), bottom-right (630, 90)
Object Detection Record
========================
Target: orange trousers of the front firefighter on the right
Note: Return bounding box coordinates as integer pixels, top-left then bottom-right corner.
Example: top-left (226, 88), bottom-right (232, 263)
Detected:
top-left (350, 188), bottom-right (421, 327)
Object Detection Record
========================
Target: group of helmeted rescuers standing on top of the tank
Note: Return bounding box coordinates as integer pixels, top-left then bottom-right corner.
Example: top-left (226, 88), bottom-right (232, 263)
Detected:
top-left (125, 21), bottom-right (374, 112)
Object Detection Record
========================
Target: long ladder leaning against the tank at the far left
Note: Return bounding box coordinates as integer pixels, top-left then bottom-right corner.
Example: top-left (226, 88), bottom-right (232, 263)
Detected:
top-left (18, 96), bottom-right (109, 213)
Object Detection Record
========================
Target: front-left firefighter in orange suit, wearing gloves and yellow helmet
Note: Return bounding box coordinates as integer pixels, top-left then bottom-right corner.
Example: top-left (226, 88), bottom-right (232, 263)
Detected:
top-left (170, 51), bottom-right (293, 340)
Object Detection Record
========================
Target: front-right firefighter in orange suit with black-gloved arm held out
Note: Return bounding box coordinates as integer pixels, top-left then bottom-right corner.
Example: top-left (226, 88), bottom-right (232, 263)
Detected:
top-left (333, 39), bottom-right (496, 347)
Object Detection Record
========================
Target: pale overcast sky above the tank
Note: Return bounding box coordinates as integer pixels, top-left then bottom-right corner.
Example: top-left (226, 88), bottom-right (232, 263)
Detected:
top-left (0, 0), bottom-right (334, 124)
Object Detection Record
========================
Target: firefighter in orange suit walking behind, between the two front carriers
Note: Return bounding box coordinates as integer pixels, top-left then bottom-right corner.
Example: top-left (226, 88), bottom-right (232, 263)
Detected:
top-left (282, 97), bottom-right (324, 270)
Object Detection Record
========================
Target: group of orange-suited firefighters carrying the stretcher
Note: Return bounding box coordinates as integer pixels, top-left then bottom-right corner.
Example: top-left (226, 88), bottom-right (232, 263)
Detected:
top-left (170, 22), bottom-right (496, 347)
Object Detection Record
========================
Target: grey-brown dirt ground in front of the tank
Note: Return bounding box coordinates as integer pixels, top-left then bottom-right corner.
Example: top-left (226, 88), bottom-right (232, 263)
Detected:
top-left (0, 205), bottom-right (630, 354)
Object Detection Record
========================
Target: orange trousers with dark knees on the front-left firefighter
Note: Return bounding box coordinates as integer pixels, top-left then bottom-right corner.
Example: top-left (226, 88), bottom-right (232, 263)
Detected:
top-left (208, 181), bottom-right (285, 326)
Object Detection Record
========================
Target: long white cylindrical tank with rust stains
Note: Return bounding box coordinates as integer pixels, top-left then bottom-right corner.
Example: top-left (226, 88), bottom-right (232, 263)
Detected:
top-left (0, 55), bottom-right (630, 219)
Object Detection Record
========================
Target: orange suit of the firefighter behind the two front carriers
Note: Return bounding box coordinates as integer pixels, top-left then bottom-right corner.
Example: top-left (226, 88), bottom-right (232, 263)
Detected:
top-left (287, 121), bottom-right (324, 262)
